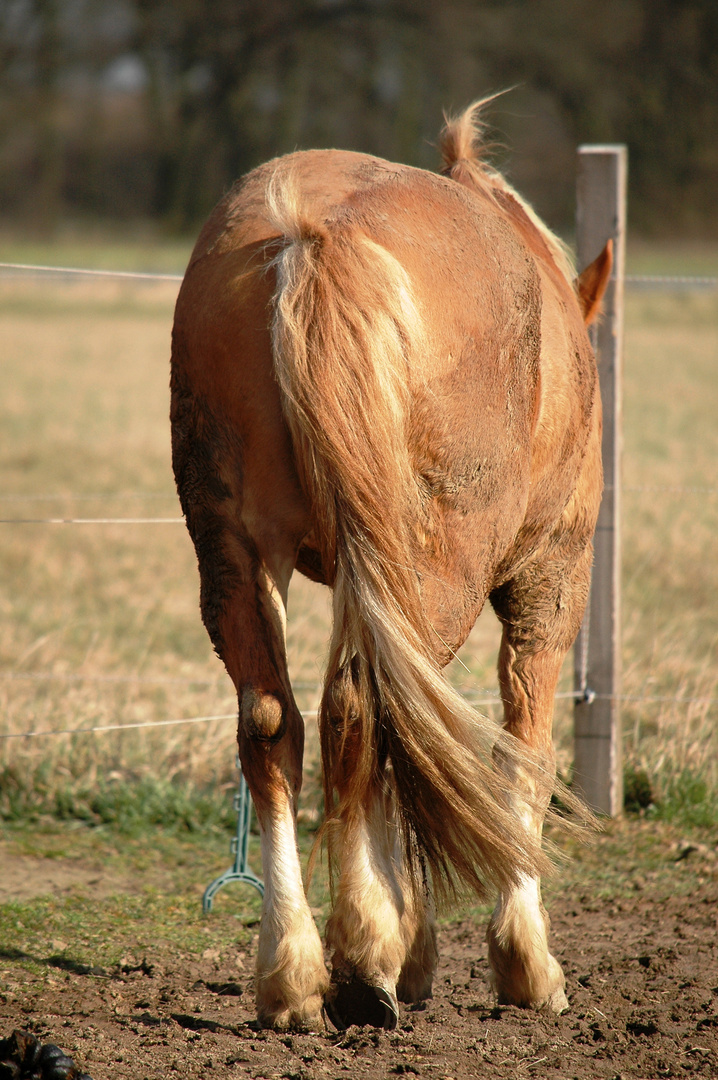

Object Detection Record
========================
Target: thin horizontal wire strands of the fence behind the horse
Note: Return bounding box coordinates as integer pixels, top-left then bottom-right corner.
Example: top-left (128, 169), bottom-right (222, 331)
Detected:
top-left (0, 262), bottom-right (718, 741)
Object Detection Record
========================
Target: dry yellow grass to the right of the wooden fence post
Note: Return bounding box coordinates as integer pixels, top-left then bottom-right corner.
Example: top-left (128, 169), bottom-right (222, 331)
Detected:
top-left (623, 292), bottom-right (718, 788)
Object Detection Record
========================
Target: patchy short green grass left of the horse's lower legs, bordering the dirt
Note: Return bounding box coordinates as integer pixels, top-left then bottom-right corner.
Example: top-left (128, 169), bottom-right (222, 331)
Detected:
top-left (0, 803), bottom-right (328, 974)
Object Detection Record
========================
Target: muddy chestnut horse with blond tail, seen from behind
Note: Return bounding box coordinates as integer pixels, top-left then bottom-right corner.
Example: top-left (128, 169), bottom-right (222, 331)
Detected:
top-left (171, 102), bottom-right (610, 1029)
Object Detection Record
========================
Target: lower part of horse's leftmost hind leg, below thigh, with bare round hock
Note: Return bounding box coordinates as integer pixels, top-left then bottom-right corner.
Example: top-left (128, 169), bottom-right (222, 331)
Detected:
top-left (207, 544), bottom-right (328, 1028)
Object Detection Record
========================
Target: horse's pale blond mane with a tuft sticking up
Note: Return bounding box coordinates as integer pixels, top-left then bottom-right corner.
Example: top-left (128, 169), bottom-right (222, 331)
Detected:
top-left (438, 97), bottom-right (575, 289)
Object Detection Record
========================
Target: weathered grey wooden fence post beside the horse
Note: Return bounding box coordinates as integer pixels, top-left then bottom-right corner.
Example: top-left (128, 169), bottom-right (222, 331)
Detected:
top-left (573, 146), bottom-right (627, 816)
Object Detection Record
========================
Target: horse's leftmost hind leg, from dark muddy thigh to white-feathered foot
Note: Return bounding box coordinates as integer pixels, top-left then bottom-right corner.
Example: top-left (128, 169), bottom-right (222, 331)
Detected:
top-left (174, 400), bottom-right (328, 1028)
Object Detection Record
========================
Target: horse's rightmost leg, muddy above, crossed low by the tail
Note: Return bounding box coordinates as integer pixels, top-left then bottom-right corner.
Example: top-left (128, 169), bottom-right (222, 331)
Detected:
top-left (487, 543), bottom-right (591, 1012)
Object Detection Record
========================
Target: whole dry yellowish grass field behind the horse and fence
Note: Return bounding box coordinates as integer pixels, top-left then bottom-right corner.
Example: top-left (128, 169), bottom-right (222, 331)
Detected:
top-left (0, 241), bottom-right (718, 828)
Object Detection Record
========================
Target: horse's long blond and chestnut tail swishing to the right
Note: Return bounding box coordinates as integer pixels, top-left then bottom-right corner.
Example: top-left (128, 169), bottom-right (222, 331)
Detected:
top-left (267, 170), bottom-right (547, 895)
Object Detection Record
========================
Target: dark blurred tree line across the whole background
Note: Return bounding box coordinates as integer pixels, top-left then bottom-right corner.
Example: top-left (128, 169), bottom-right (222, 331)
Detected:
top-left (0, 0), bottom-right (718, 233)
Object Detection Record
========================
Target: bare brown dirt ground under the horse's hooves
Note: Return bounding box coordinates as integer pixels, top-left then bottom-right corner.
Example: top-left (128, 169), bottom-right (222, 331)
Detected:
top-left (0, 853), bottom-right (718, 1080)
